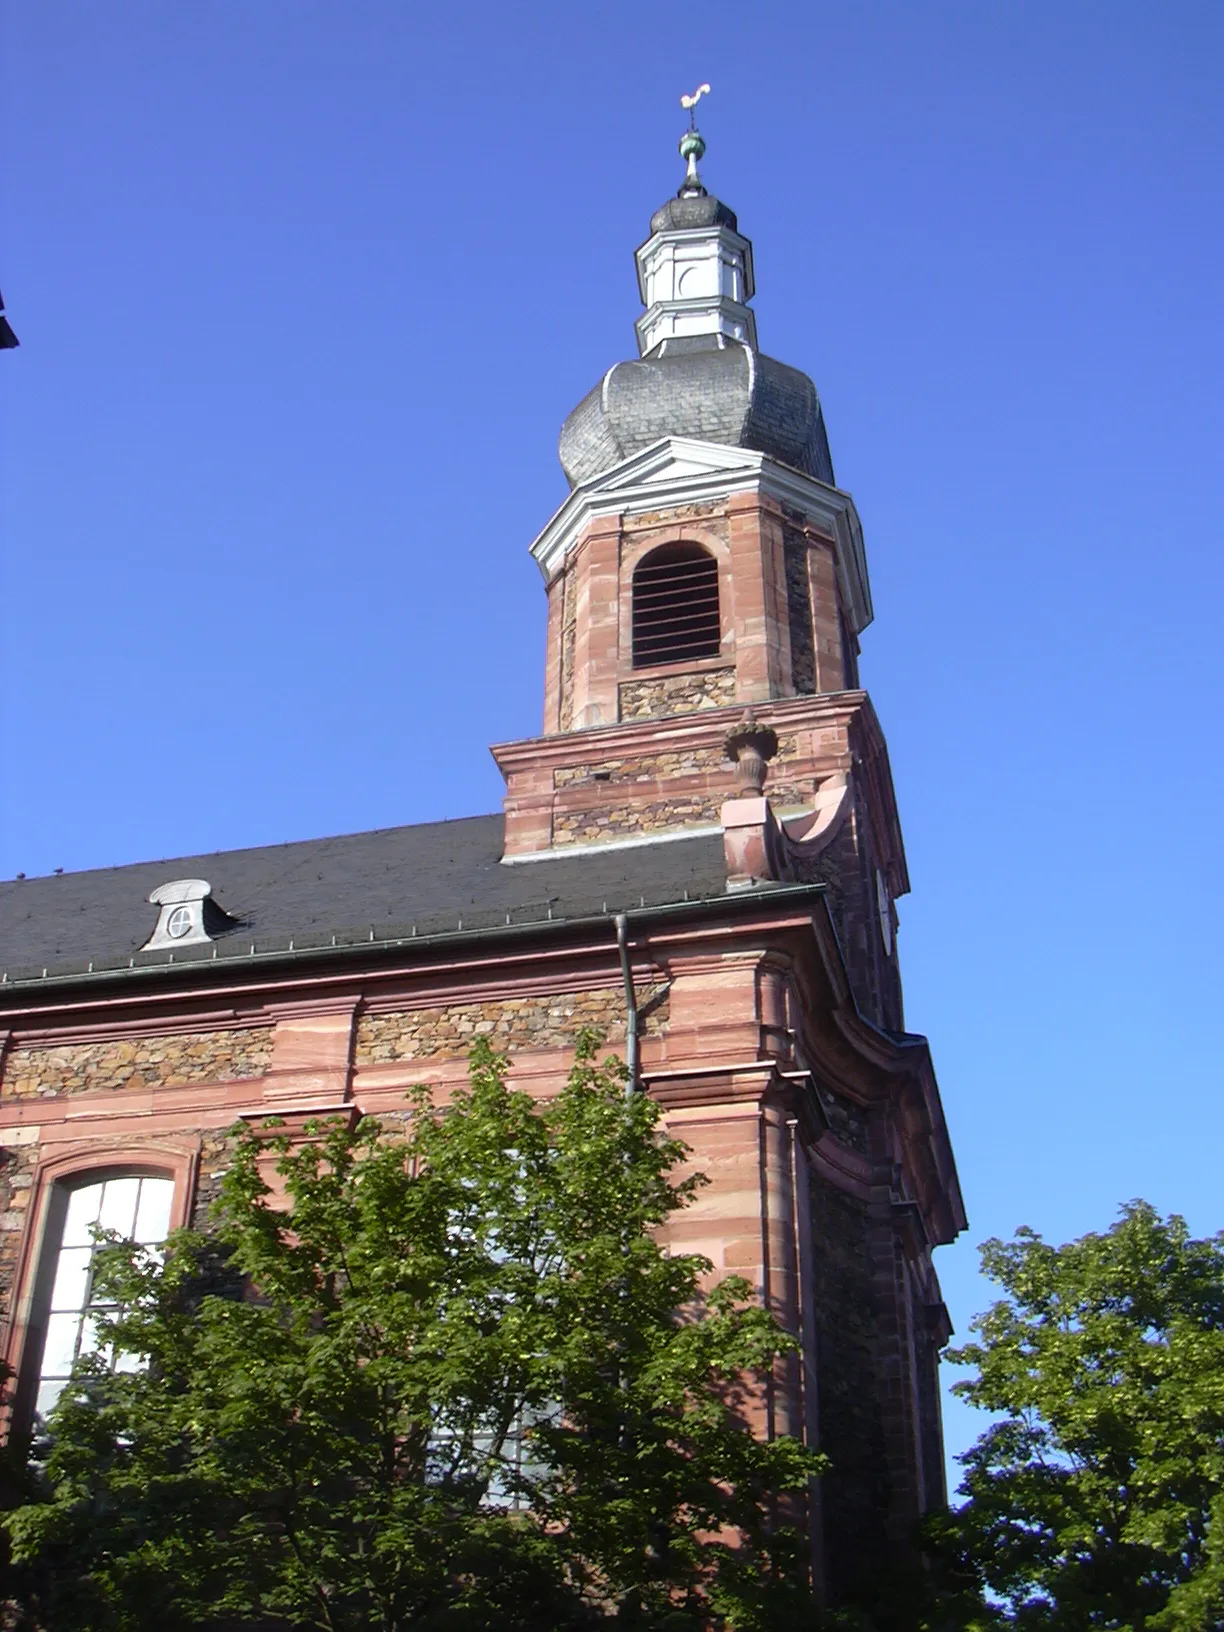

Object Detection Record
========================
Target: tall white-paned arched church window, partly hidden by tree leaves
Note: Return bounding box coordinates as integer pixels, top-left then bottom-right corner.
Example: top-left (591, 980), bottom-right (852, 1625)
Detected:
top-left (34, 1172), bottom-right (175, 1418)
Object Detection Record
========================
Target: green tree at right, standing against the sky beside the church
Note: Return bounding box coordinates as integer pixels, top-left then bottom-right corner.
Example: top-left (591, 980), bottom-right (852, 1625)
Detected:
top-left (929, 1201), bottom-right (1224, 1632)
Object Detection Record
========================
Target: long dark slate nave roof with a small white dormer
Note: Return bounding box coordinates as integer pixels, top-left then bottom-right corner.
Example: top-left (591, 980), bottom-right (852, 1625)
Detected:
top-left (0, 814), bottom-right (744, 992)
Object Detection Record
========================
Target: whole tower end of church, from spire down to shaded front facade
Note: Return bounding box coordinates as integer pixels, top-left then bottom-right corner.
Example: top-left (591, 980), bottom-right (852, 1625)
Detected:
top-left (493, 118), bottom-right (965, 1603)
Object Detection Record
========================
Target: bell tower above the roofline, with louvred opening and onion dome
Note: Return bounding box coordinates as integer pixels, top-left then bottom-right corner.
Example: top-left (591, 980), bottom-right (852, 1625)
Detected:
top-left (493, 129), bottom-right (909, 1027)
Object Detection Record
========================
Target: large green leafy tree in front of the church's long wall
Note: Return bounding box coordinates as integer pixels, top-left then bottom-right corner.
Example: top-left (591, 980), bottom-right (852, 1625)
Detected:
top-left (7, 1038), bottom-right (819, 1632)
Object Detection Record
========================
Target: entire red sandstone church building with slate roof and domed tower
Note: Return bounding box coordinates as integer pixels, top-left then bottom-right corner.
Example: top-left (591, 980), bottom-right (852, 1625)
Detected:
top-left (0, 118), bottom-right (965, 1603)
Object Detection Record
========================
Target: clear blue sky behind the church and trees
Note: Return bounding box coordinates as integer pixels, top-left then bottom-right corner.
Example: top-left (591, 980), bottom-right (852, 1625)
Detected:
top-left (0, 0), bottom-right (1224, 1481)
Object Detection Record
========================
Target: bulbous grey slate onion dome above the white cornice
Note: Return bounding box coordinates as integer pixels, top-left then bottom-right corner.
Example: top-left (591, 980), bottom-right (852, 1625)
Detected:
top-left (558, 335), bottom-right (832, 486)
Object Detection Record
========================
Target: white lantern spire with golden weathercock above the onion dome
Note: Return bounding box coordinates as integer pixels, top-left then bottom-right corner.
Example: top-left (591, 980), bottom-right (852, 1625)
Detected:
top-left (636, 85), bottom-right (757, 357)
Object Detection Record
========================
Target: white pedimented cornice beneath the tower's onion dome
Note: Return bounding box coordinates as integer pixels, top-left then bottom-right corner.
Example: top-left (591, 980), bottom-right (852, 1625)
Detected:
top-left (532, 436), bottom-right (873, 635)
